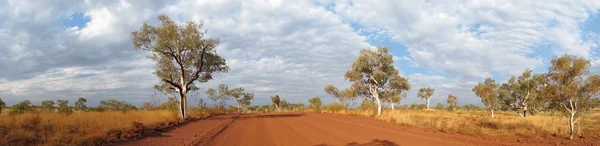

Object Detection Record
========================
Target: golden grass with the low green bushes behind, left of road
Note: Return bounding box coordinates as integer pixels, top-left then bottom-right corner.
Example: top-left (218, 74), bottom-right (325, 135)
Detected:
top-left (0, 98), bottom-right (227, 145)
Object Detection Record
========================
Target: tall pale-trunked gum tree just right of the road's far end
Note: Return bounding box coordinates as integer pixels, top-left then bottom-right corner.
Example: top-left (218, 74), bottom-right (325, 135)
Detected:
top-left (344, 46), bottom-right (410, 116)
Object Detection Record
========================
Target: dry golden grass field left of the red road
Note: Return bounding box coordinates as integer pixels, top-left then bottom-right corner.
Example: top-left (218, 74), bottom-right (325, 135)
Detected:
top-left (0, 110), bottom-right (209, 145)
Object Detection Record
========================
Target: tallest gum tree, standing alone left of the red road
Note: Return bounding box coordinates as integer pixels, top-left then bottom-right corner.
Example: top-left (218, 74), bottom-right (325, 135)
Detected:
top-left (131, 15), bottom-right (229, 118)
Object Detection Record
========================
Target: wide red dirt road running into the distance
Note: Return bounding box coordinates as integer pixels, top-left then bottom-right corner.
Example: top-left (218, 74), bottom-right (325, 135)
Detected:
top-left (123, 113), bottom-right (584, 146)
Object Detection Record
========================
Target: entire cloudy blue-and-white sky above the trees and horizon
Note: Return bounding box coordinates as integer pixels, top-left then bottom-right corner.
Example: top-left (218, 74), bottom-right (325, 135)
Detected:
top-left (0, 0), bottom-right (600, 105)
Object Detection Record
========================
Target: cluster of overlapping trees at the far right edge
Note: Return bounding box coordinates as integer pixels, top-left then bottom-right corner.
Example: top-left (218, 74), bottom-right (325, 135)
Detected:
top-left (473, 55), bottom-right (600, 139)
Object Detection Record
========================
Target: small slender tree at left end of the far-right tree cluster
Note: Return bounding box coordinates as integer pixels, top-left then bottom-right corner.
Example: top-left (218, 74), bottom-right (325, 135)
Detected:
top-left (473, 78), bottom-right (498, 118)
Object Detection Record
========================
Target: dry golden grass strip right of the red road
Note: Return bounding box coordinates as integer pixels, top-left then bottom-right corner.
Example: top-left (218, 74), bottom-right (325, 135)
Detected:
top-left (326, 110), bottom-right (600, 140)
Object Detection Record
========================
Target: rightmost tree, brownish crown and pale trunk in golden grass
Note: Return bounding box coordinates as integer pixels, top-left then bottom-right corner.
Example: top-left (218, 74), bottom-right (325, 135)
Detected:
top-left (544, 55), bottom-right (600, 139)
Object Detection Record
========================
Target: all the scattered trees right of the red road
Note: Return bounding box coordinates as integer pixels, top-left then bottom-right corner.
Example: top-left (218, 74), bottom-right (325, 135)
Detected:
top-left (322, 47), bottom-right (600, 139)
